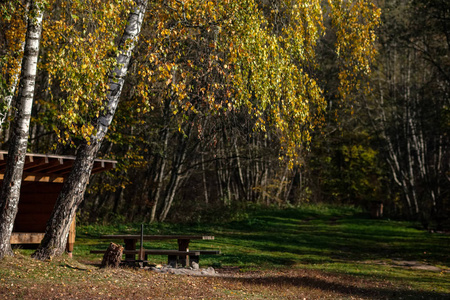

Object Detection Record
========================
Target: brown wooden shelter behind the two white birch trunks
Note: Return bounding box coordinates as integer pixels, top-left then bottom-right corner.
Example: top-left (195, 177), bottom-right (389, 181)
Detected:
top-left (0, 151), bottom-right (116, 253)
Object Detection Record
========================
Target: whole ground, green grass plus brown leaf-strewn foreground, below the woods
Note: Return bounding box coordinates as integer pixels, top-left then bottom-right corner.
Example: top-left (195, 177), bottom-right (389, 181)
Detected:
top-left (0, 206), bottom-right (450, 299)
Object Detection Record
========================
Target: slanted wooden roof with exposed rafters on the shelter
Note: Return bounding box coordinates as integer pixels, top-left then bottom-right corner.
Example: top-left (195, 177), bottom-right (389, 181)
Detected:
top-left (0, 150), bottom-right (117, 183)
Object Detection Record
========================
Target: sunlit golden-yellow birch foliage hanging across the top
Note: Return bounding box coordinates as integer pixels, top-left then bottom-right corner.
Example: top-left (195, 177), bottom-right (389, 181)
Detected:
top-left (2, 0), bottom-right (380, 165)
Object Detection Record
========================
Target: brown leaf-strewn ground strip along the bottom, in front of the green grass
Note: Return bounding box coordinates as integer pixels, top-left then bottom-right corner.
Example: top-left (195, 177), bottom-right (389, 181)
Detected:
top-left (0, 265), bottom-right (442, 299)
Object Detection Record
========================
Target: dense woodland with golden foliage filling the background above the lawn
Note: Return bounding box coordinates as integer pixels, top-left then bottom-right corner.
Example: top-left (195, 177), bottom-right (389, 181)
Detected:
top-left (0, 0), bottom-right (450, 258)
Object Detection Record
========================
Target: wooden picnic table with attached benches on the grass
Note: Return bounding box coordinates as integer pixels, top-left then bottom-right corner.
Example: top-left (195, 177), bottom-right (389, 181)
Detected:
top-left (101, 234), bottom-right (216, 266)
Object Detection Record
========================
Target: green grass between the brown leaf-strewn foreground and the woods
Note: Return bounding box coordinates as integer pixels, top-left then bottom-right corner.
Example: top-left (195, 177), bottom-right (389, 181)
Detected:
top-left (14, 206), bottom-right (450, 299)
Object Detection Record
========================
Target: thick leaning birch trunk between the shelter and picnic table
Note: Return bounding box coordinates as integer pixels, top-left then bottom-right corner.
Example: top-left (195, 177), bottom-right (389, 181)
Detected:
top-left (32, 0), bottom-right (147, 260)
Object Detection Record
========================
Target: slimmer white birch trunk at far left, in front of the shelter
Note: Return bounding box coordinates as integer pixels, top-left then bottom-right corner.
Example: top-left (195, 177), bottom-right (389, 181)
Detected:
top-left (0, 1), bottom-right (43, 259)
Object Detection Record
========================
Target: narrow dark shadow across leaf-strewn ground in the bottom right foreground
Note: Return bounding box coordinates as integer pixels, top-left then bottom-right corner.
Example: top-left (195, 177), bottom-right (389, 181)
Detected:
top-left (221, 276), bottom-right (450, 300)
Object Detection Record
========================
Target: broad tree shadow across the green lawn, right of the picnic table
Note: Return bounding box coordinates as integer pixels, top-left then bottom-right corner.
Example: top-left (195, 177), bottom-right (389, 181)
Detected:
top-left (215, 210), bottom-right (450, 268)
